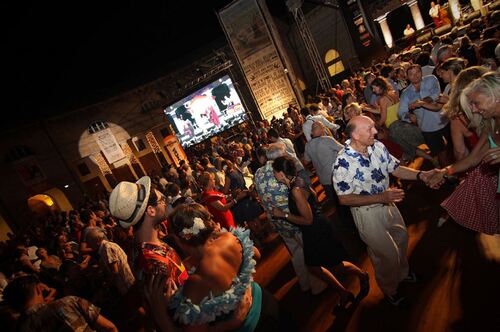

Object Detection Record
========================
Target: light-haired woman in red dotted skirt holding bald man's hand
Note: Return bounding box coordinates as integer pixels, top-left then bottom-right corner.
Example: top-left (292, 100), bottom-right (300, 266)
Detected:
top-left (431, 72), bottom-right (500, 234)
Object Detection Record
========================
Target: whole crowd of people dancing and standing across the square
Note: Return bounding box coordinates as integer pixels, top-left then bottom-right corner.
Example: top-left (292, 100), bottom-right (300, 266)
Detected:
top-left (0, 9), bottom-right (500, 331)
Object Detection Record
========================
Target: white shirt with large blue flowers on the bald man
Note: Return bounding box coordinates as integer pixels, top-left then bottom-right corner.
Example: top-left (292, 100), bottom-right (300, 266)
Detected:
top-left (332, 140), bottom-right (399, 196)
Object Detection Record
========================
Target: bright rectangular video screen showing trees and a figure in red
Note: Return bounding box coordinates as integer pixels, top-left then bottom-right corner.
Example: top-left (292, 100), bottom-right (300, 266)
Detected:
top-left (165, 75), bottom-right (247, 148)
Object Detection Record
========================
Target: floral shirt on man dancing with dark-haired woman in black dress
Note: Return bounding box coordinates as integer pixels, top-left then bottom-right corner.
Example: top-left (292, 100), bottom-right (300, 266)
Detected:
top-left (253, 160), bottom-right (300, 237)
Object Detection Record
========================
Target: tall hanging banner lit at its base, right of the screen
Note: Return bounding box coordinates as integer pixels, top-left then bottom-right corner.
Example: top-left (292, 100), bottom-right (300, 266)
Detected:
top-left (218, 0), bottom-right (298, 120)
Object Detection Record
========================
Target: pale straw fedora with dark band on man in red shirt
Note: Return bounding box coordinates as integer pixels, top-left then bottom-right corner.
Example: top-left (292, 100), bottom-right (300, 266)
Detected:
top-left (109, 176), bottom-right (151, 228)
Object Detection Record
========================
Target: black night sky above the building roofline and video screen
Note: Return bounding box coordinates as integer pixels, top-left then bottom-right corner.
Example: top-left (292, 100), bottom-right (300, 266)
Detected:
top-left (0, 0), bottom-right (241, 128)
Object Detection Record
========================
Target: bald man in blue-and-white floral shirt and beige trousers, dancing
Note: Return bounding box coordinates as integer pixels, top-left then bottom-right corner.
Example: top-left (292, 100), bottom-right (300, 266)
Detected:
top-left (333, 116), bottom-right (434, 306)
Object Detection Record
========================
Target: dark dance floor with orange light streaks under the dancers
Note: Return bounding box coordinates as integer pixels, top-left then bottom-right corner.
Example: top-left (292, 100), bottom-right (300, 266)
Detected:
top-left (256, 175), bottom-right (500, 332)
